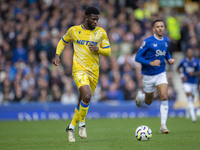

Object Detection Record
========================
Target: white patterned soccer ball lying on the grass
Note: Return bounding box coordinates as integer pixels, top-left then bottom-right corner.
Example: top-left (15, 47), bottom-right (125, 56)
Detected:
top-left (135, 125), bottom-right (152, 141)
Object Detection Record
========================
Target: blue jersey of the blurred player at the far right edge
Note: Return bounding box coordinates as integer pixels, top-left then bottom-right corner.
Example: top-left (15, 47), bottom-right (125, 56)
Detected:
top-left (178, 57), bottom-right (200, 84)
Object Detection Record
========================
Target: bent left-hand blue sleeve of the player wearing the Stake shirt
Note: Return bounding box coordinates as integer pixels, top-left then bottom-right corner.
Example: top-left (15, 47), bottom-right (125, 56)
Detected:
top-left (135, 41), bottom-right (151, 65)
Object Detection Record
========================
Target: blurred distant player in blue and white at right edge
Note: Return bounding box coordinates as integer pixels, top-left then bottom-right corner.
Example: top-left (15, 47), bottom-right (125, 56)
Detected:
top-left (177, 48), bottom-right (200, 122)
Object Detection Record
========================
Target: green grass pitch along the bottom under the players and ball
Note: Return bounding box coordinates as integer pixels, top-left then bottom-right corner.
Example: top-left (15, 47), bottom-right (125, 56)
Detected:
top-left (0, 118), bottom-right (200, 150)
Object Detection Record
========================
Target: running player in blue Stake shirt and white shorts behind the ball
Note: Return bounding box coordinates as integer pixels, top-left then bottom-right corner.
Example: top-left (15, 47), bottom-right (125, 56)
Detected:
top-left (135, 20), bottom-right (175, 134)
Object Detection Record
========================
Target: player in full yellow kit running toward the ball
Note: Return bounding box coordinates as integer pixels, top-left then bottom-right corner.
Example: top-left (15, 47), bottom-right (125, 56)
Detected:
top-left (53, 7), bottom-right (111, 142)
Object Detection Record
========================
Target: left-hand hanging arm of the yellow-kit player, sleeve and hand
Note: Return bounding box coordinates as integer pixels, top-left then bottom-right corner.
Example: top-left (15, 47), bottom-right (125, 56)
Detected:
top-left (52, 28), bottom-right (72, 66)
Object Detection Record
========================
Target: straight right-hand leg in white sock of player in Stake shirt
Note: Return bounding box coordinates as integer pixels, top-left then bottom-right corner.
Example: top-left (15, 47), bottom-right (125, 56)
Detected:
top-left (157, 84), bottom-right (169, 134)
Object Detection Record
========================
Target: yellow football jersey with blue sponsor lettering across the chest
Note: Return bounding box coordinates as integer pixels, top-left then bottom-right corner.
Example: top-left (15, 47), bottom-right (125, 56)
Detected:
top-left (62, 24), bottom-right (110, 73)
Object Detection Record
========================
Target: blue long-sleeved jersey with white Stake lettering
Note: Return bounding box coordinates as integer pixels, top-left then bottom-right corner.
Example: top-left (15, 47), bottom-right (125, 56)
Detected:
top-left (135, 35), bottom-right (171, 75)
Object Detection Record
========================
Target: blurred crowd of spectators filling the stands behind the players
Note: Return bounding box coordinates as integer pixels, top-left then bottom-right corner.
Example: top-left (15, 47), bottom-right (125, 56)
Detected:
top-left (0, 0), bottom-right (200, 104)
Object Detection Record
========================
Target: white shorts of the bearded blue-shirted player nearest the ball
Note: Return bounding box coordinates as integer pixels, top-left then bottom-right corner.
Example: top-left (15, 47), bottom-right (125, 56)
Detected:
top-left (142, 72), bottom-right (168, 93)
